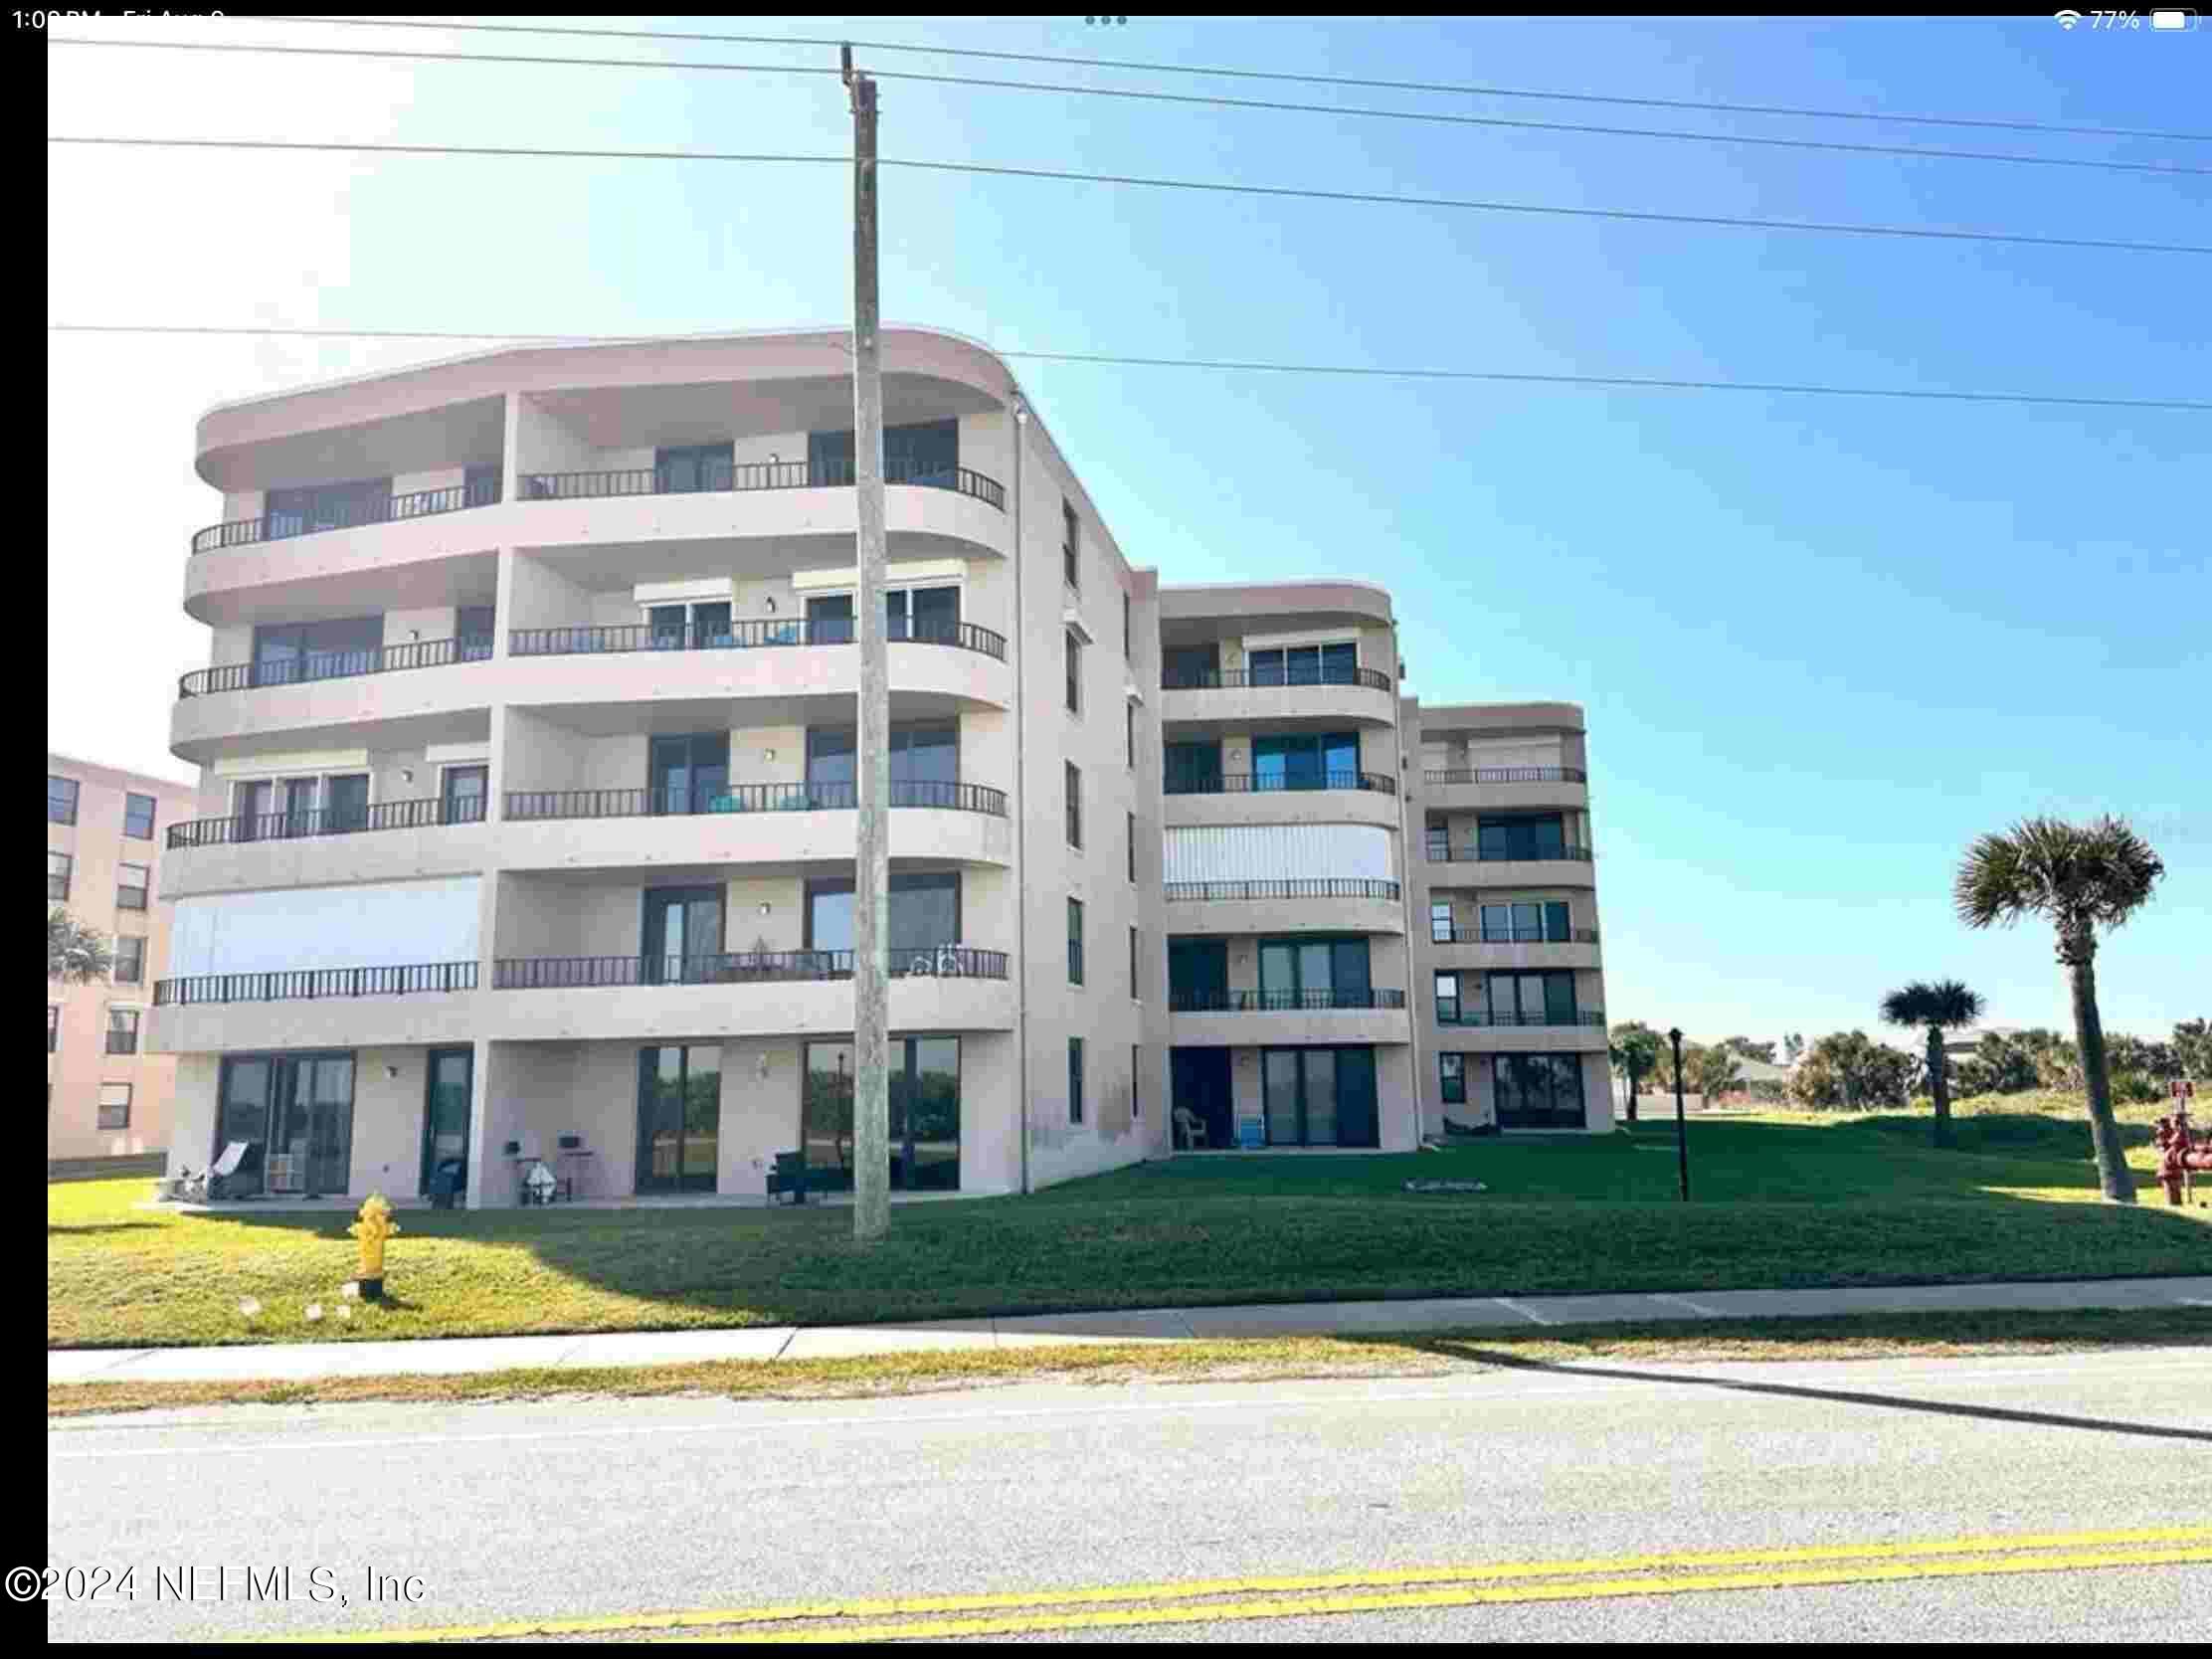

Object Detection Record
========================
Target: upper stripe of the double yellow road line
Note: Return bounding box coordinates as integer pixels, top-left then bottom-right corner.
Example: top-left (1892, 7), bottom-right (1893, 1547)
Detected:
top-left (302, 1527), bottom-right (2212, 1641)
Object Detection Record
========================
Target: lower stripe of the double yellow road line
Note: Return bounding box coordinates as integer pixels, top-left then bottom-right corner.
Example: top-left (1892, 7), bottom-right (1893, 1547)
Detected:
top-left (657, 1549), bottom-right (2212, 1641)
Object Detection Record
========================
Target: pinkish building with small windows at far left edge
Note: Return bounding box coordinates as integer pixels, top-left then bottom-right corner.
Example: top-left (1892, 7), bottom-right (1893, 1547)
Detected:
top-left (47, 752), bottom-right (192, 1159)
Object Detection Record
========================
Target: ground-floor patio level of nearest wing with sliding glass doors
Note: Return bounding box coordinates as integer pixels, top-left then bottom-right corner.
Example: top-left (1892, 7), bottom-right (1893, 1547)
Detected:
top-left (168, 1030), bottom-right (1043, 1212)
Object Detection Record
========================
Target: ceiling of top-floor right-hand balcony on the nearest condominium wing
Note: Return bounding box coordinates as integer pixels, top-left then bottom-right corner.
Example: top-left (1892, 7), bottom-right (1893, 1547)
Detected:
top-left (531, 374), bottom-right (998, 461)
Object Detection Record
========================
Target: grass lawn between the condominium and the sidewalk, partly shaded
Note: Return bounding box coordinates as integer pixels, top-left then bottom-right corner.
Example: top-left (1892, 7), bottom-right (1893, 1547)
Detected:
top-left (47, 1097), bottom-right (2212, 1347)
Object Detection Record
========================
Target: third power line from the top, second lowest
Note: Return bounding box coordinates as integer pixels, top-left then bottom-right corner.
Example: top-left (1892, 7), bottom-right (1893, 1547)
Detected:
top-left (47, 135), bottom-right (2212, 255)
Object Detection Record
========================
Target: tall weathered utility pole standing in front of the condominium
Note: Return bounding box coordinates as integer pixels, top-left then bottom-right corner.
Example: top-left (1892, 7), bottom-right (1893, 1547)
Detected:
top-left (840, 47), bottom-right (891, 1243)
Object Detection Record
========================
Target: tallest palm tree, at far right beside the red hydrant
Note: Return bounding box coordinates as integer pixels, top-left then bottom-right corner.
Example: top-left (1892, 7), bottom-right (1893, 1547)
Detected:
top-left (1951, 817), bottom-right (2165, 1203)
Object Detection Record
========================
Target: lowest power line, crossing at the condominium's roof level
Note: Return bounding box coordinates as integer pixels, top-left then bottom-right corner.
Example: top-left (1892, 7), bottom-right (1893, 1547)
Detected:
top-left (47, 323), bottom-right (2212, 414)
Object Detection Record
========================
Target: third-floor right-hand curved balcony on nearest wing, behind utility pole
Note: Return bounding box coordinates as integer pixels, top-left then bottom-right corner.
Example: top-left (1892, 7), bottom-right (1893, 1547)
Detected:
top-left (500, 779), bottom-right (1014, 869)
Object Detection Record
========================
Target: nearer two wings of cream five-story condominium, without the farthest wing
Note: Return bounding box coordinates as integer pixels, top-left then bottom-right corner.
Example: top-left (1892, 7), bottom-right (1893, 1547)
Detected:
top-left (150, 329), bottom-right (1603, 1205)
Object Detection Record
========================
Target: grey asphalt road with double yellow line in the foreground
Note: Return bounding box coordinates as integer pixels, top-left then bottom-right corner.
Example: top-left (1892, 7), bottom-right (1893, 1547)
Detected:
top-left (31, 1350), bottom-right (2212, 1641)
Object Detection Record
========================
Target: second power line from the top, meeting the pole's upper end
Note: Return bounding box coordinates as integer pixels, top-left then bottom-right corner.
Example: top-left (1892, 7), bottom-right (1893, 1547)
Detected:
top-left (47, 36), bottom-right (2212, 175)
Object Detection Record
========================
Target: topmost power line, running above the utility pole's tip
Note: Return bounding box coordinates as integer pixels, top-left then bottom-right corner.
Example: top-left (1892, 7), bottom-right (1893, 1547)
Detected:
top-left (259, 18), bottom-right (2212, 144)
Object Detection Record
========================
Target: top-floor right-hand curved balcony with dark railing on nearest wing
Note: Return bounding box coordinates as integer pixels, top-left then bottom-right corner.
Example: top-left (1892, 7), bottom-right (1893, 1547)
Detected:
top-left (513, 461), bottom-right (1011, 555)
